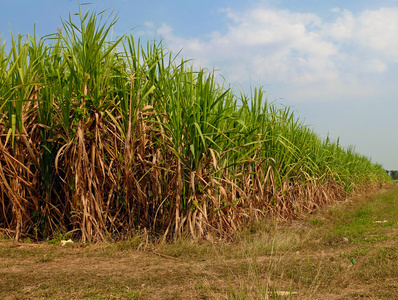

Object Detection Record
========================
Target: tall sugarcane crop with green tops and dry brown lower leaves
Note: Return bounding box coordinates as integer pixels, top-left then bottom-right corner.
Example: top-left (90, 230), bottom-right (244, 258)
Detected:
top-left (0, 6), bottom-right (388, 241)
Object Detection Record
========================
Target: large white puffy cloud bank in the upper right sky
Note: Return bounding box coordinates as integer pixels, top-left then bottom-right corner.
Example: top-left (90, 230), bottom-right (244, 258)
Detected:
top-left (148, 6), bottom-right (398, 101)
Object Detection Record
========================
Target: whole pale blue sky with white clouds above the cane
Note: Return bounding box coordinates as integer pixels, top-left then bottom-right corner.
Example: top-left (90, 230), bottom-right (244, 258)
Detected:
top-left (0, 0), bottom-right (398, 170)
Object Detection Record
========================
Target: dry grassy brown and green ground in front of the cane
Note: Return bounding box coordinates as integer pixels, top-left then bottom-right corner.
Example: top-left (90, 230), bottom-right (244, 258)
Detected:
top-left (0, 187), bottom-right (398, 299)
